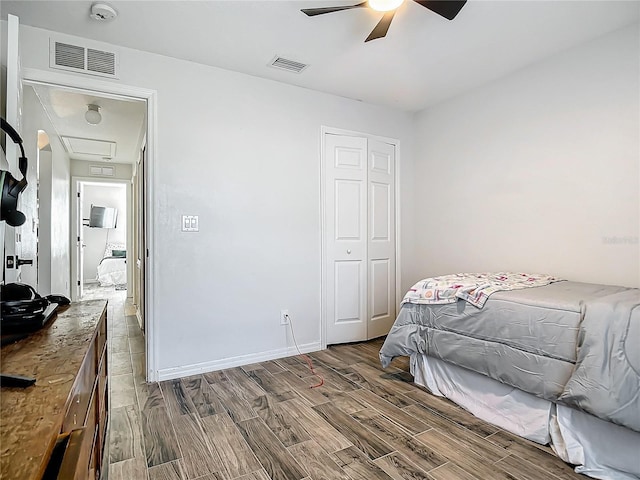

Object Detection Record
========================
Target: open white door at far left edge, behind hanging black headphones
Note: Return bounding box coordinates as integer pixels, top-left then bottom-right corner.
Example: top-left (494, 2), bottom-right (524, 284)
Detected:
top-left (0, 15), bottom-right (22, 283)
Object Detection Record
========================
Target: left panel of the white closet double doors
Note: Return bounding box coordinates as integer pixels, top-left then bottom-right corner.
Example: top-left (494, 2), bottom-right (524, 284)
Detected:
top-left (325, 134), bottom-right (367, 344)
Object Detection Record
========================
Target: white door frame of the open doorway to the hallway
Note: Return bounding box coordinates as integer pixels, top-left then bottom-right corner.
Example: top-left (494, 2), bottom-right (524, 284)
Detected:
top-left (22, 68), bottom-right (160, 382)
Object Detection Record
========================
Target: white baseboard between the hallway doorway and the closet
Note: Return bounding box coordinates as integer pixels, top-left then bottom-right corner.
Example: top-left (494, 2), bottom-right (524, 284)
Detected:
top-left (158, 342), bottom-right (322, 382)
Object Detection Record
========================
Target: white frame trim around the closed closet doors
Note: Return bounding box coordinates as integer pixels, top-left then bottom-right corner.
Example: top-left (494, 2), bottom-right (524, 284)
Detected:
top-left (320, 125), bottom-right (402, 350)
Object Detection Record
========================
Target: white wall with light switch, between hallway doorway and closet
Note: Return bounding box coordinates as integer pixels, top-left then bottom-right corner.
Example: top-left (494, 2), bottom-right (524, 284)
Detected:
top-left (21, 26), bottom-right (412, 376)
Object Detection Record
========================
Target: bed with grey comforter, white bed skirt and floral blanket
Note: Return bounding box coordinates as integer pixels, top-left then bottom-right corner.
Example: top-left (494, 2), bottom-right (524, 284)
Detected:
top-left (380, 272), bottom-right (640, 479)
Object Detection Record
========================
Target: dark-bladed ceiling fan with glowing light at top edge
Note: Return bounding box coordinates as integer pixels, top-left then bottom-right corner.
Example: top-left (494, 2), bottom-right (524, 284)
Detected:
top-left (301, 0), bottom-right (467, 42)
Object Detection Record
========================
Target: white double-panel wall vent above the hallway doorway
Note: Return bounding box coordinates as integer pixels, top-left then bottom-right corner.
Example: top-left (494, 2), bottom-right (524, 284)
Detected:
top-left (49, 39), bottom-right (118, 78)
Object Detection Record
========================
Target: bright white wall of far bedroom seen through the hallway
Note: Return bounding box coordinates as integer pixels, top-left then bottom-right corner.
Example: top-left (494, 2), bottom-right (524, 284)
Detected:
top-left (82, 183), bottom-right (127, 283)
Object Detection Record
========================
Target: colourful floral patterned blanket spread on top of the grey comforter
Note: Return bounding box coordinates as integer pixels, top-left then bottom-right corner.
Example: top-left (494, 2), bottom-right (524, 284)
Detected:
top-left (402, 272), bottom-right (562, 308)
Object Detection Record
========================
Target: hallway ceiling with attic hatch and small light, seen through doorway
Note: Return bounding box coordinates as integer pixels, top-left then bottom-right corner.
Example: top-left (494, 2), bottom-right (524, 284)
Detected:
top-left (26, 85), bottom-right (146, 163)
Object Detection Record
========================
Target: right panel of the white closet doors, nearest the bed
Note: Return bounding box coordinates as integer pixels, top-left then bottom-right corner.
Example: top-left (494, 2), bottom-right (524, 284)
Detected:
top-left (367, 139), bottom-right (396, 339)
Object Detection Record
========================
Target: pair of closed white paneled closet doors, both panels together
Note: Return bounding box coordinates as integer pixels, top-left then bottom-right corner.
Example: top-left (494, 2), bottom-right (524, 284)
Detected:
top-left (321, 129), bottom-right (399, 345)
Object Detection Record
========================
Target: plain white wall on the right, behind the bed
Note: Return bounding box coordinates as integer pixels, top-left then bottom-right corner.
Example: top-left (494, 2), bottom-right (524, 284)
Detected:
top-left (407, 25), bottom-right (640, 287)
